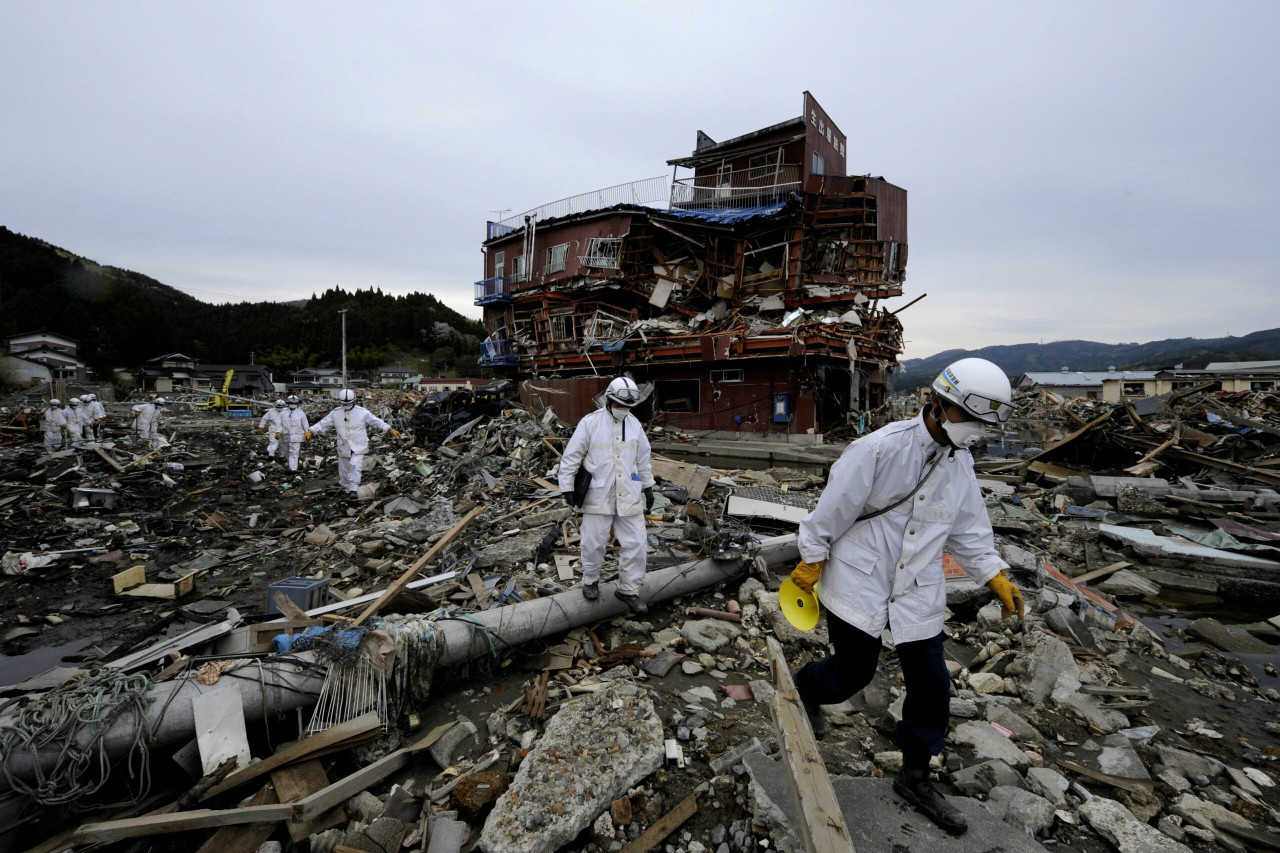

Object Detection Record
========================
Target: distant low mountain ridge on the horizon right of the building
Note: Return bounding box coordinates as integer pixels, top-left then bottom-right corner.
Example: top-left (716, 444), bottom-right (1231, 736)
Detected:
top-left (893, 329), bottom-right (1280, 391)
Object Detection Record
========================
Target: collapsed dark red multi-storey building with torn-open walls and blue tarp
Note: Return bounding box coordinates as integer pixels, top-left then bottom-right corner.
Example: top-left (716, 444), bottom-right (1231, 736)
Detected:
top-left (475, 92), bottom-right (908, 437)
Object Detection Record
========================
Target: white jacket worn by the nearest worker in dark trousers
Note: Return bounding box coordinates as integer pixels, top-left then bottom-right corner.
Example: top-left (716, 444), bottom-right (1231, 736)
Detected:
top-left (797, 415), bottom-right (1009, 644)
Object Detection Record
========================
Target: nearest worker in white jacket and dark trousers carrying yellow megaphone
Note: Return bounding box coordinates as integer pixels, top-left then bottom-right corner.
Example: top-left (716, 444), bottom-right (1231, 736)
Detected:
top-left (791, 359), bottom-right (1025, 835)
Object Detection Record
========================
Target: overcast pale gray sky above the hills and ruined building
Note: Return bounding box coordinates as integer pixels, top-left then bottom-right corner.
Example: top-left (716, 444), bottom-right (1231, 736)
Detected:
top-left (0, 0), bottom-right (1280, 357)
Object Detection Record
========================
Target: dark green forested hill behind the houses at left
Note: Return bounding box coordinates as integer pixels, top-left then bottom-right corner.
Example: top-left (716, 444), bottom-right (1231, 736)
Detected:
top-left (0, 225), bottom-right (484, 375)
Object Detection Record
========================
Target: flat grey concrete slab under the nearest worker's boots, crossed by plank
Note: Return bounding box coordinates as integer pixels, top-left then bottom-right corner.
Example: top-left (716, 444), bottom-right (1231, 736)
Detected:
top-left (746, 753), bottom-right (1043, 853)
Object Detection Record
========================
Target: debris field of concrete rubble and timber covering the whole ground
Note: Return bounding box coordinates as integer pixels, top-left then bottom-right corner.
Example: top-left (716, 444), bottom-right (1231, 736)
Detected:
top-left (0, 389), bottom-right (1280, 853)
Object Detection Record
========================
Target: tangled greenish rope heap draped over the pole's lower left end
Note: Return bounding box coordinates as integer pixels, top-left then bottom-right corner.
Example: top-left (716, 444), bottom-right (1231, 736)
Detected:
top-left (0, 667), bottom-right (151, 806)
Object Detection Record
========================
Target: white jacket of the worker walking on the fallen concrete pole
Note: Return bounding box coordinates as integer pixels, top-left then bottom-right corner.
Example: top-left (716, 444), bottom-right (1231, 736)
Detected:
top-left (559, 409), bottom-right (653, 515)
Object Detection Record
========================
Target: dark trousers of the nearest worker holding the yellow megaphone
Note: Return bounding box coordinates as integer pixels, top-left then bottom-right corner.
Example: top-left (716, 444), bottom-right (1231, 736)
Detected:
top-left (795, 611), bottom-right (951, 768)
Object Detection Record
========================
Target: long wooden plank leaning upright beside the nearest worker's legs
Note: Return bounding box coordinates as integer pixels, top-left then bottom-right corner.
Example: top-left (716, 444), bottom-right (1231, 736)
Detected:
top-left (768, 637), bottom-right (854, 853)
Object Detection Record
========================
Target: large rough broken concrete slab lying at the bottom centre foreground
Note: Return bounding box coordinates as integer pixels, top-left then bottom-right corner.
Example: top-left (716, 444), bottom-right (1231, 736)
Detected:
top-left (479, 683), bottom-right (666, 853)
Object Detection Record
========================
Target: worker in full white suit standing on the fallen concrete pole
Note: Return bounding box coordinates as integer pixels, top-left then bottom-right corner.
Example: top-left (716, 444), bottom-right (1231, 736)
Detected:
top-left (559, 377), bottom-right (653, 613)
